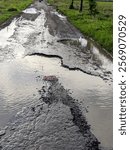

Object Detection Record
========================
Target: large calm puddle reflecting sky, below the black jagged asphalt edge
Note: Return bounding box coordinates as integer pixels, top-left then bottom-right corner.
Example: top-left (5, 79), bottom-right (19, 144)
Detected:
top-left (0, 56), bottom-right (112, 147)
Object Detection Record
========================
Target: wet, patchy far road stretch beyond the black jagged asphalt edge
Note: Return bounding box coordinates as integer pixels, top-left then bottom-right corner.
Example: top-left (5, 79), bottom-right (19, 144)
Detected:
top-left (0, 1), bottom-right (112, 81)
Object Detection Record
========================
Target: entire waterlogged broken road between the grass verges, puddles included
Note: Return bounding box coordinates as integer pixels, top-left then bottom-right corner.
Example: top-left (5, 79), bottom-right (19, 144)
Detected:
top-left (0, 2), bottom-right (112, 150)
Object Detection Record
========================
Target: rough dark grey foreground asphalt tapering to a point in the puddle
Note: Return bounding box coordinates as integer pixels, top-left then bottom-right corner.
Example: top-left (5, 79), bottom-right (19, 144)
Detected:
top-left (0, 77), bottom-right (99, 150)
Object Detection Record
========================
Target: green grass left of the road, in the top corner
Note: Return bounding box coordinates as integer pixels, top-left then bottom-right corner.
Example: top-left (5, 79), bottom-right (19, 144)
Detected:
top-left (0, 0), bottom-right (33, 24)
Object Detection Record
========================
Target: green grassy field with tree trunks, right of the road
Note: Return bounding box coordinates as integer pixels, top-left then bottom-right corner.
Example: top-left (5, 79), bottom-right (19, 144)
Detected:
top-left (48, 0), bottom-right (113, 54)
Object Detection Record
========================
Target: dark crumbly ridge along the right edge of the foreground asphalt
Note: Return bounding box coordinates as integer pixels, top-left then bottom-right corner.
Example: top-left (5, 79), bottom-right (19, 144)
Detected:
top-left (40, 79), bottom-right (100, 150)
